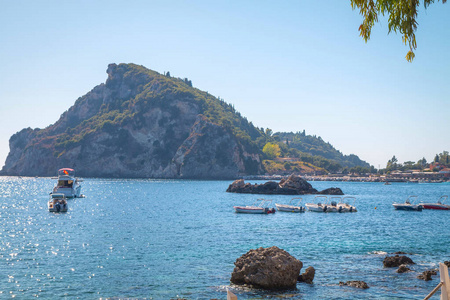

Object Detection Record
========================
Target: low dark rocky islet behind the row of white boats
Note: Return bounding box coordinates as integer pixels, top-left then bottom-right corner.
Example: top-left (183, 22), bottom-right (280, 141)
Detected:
top-left (227, 175), bottom-right (344, 195)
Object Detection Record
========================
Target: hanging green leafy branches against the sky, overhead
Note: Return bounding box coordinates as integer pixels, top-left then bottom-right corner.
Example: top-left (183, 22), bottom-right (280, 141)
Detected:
top-left (351, 0), bottom-right (447, 62)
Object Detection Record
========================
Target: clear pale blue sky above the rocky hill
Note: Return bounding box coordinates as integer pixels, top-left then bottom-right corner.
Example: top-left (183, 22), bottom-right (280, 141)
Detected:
top-left (0, 0), bottom-right (450, 168)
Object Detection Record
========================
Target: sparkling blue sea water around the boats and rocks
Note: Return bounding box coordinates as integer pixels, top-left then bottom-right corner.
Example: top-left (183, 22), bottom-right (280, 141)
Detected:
top-left (0, 177), bottom-right (450, 299)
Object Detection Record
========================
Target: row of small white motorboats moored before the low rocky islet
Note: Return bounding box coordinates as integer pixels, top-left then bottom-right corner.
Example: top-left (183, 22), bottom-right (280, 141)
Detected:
top-left (233, 196), bottom-right (358, 214)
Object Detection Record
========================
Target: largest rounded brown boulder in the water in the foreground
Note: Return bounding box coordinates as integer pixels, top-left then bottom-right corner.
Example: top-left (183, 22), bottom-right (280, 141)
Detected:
top-left (230, 246), bottom-right (303, 289)
